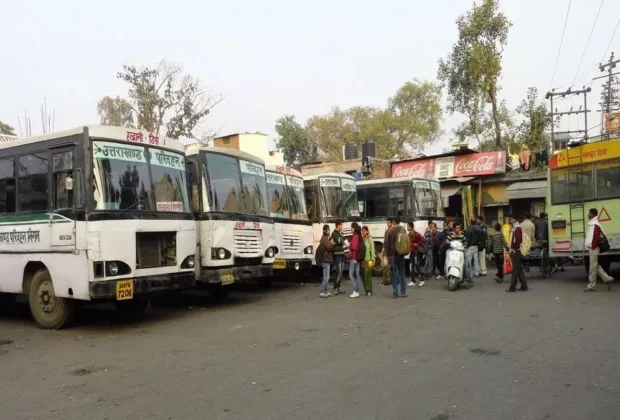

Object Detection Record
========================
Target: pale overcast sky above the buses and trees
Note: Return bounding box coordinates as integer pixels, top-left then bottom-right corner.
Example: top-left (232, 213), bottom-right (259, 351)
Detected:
top-left (0, 0), bottom-right (620, 154)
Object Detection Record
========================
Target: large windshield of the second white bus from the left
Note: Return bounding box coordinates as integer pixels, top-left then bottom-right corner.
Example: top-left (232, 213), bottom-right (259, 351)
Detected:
top-left (203, 152), bottom-right (269, 216)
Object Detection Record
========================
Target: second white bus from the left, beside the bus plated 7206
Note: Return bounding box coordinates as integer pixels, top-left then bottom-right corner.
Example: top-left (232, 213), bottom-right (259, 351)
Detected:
top-left (186, 145), bottom-right (276, 298)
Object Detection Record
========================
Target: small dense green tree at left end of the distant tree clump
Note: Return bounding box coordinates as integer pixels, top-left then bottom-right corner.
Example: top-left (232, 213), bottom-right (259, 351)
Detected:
top-left (275, 115), bottom-right (318, 166)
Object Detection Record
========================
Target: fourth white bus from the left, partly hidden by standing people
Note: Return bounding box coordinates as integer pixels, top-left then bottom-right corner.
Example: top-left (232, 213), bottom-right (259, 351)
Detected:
top-left (304, 173), bottom-right (361, 266)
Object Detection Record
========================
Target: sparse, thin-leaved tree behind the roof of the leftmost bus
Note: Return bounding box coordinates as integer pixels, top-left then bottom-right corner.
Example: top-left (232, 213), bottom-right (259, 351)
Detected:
top-left (98, 60), bottom-right (222, 139)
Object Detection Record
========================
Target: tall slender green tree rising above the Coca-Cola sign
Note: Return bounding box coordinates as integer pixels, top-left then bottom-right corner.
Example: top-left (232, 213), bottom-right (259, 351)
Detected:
top-left (438, 0), bottom-right (512, 147)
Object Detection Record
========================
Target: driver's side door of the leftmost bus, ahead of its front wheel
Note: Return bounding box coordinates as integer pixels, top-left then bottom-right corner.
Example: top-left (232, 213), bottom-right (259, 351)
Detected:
top-left (49, 145), bottom-right (77, 249)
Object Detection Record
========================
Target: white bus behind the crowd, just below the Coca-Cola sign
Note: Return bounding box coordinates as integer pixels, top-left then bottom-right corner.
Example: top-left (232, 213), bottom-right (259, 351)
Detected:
top-left (357, 178), bottom-right (445, 275)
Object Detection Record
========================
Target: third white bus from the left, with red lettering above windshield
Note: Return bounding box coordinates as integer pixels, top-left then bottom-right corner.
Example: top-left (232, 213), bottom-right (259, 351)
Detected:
top-left (266, 165), bottom-right (313, 280)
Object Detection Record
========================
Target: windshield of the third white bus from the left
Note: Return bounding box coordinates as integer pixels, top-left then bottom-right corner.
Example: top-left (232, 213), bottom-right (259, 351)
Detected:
top-left (267, 172), bottom-right (308, 220)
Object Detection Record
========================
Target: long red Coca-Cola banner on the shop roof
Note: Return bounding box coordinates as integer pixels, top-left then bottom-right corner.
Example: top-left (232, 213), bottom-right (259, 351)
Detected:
top-left (392, 151), bottom-right (506, 178)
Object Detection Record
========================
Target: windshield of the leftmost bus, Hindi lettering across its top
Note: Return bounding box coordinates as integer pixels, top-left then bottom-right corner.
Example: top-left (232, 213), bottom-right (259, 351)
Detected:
top-left (93, 141), bottom-right (189, 212)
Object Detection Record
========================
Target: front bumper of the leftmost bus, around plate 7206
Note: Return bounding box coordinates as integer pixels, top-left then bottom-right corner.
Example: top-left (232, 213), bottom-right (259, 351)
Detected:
top-left (89, 271), bottom-right (196, 301)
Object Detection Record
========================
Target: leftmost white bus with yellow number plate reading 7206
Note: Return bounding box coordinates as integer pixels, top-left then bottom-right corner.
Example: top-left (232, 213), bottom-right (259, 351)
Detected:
top-left (0, 126), bottom-right (196, 329)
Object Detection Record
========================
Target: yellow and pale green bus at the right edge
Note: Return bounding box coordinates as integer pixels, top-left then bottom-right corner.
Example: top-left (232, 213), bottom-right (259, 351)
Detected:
top-left (546, 140), bottom-right (620, 270)
